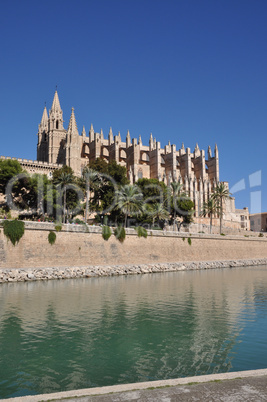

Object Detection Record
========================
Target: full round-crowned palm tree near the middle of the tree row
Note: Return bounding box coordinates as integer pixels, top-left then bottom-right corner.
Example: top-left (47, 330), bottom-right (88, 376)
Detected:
top-left (116, 184), bottom-right (143, 227)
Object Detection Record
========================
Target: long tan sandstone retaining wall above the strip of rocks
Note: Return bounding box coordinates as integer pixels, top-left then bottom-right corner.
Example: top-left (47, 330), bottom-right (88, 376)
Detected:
top-left (0, 228), bottom-right (267, 269)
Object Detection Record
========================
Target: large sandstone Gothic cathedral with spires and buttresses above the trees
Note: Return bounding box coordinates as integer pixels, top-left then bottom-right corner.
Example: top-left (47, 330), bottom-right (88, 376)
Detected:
top-left (37, 91), bottom-right (222, 215)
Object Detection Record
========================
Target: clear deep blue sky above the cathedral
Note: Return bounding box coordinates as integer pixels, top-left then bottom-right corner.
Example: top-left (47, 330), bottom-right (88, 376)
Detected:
top-left (0, 0), bottom-right (267, 212)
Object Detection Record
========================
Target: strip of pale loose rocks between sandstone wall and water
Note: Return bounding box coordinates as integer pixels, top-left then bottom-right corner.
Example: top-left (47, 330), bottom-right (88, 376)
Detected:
top-left (0, 258), bottom-right (267, 283)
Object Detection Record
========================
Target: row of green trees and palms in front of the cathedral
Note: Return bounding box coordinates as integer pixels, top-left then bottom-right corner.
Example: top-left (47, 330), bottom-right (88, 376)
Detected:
top-left (0, 158), bottom-right (229, 230)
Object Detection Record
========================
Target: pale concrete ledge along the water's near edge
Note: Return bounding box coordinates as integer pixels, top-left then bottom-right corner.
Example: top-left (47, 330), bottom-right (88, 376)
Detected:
top-left (3, 369), bottom-right (267, 402)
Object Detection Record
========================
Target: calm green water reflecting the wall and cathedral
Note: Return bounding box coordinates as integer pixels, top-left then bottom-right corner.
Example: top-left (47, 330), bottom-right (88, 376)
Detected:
top-left (0, 266), bottom-right (267, 398)
